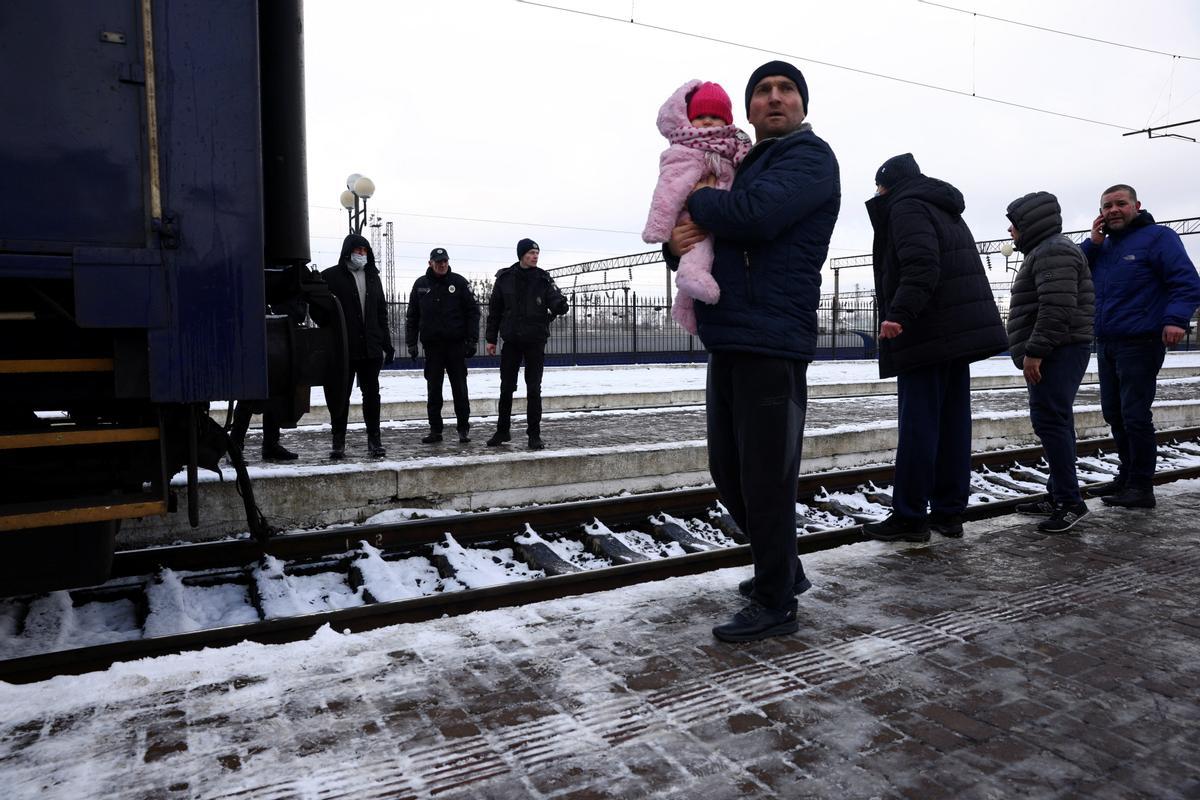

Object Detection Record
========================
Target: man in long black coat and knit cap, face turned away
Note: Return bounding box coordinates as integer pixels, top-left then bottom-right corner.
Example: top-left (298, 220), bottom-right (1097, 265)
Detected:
top-left (864, 152), bottom-right (1008, 541)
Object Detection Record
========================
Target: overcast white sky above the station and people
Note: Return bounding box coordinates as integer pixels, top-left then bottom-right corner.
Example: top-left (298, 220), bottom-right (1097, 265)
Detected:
top-left (305, 0), bottom-right (1200, 295)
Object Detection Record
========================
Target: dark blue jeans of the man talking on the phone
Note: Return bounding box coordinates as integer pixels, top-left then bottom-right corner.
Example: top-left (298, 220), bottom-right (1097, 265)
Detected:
top-left (1096, 333), bottom-right (1166, 488)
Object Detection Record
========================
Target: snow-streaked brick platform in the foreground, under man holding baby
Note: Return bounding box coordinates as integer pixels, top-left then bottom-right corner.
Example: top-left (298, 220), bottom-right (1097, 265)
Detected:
top-left (0, 481), bottom-right (1200, 800)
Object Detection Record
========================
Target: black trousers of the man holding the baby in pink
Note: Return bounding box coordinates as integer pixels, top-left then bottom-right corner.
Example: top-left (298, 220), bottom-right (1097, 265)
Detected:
top-left (707, 353), bottom-right (809, 610)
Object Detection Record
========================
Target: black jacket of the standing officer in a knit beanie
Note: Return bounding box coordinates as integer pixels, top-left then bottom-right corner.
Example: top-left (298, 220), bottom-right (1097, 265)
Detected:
top-left (485, 261), bottom-right (570, 344)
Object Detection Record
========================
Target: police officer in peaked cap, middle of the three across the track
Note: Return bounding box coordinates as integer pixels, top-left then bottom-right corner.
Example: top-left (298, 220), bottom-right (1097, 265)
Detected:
top-left (404, 247), bottom-right (479, 445)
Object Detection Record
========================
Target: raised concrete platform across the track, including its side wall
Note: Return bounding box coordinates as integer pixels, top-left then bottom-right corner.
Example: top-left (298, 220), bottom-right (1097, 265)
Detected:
top-left (118, 379), bottom-right (1200, 547)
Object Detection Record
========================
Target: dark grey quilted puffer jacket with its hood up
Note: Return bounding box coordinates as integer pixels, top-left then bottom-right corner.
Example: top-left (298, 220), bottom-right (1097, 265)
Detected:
top-left (1008, 192), bottom-right (1096, 367)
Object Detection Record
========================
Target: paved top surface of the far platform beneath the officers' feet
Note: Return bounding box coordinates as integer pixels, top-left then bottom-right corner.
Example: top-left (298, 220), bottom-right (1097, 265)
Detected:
top-left (236, 379), bottom-right (1200, 470)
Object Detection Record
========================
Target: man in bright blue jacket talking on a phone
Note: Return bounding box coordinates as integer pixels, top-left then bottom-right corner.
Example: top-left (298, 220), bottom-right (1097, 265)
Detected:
top-left (1081, 184), bottom-right (1200, 509)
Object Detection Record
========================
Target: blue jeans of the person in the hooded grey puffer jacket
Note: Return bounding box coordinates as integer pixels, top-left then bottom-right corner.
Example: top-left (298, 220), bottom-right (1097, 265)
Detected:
top-left (1027, 344), bottom-right (1092, 505)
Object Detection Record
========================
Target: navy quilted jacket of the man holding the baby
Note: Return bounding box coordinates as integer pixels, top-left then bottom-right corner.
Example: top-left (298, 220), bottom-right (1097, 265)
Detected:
top-left (688, 124), bottom-right (841, 361)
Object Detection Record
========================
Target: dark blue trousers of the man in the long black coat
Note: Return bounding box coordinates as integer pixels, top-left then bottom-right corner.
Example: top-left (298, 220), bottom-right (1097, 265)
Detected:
top-left (892, 361), bottom-right (971, 519)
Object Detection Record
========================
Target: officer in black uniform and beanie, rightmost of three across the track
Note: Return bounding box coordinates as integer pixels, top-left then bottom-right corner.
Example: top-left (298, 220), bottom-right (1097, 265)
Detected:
top-left (486, 239), bottom-right (569, 450)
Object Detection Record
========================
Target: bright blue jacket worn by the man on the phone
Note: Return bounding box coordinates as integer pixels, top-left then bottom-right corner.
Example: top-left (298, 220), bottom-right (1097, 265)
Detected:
top-left (1080, 211), bottom-right (1200, 338)
